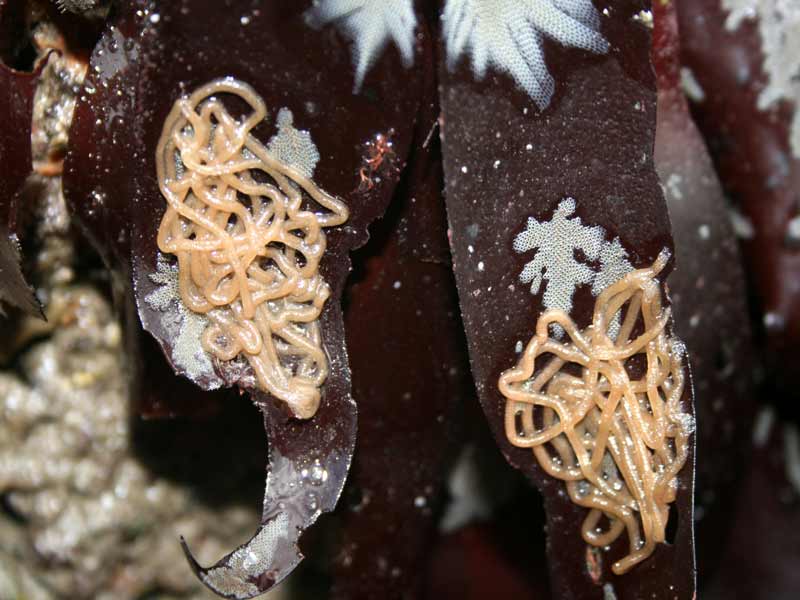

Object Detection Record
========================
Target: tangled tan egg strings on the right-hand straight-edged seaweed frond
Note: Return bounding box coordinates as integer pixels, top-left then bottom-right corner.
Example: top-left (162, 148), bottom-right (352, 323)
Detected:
top-left (499, 251), bottom-right (694, 575)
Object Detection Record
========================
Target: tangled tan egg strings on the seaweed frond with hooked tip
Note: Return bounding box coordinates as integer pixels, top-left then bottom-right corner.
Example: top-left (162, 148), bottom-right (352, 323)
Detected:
top-left (156, 78), bottom-right (348, 418)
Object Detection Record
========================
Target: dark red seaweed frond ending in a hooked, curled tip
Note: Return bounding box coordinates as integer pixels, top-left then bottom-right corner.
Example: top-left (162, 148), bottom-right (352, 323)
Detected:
top-left (64, 0), bottom-right (432, 598)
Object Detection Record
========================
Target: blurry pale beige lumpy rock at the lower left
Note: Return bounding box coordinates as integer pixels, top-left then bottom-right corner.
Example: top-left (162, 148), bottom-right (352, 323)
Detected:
top-left (0, 284), bottom-right (257, 600)
